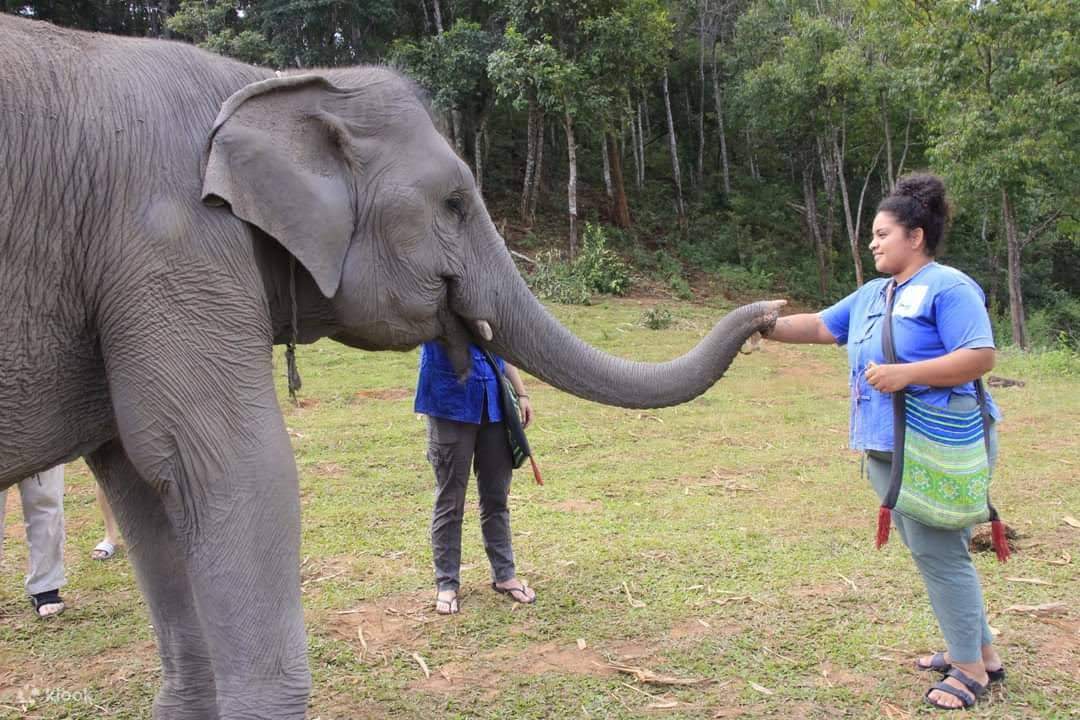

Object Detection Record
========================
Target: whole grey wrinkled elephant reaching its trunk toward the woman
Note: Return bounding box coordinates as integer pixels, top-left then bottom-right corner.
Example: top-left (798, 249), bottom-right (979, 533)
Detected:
top-left (0, 15), bottom-right (775, 720)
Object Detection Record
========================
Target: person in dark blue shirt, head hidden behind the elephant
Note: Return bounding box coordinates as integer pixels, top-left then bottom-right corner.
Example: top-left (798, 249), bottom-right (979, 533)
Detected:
top-left (414, 342), bottom-right (536, 615)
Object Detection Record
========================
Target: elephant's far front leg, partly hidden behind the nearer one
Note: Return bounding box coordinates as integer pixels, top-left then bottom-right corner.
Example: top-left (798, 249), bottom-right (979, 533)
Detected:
top-left (86, 440), bottom-right (218, 720)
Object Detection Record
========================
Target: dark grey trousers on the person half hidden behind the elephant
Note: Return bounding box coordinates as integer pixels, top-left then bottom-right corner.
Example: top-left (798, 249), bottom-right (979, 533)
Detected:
top-left (428, 416), bottom-right (515, 590)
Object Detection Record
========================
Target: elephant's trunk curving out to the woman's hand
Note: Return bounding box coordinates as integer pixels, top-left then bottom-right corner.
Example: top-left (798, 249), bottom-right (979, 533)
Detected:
top-left (467, 235), bottom-right (783, 408)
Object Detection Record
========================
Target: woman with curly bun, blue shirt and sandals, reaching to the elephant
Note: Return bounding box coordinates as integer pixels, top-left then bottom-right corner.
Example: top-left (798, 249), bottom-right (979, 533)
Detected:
top-left (768, 175), bottom-right (1004, 709)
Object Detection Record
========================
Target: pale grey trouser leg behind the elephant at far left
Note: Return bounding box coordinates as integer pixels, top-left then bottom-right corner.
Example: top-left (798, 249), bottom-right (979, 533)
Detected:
top-left (0, 465), bottom-right (67, 595)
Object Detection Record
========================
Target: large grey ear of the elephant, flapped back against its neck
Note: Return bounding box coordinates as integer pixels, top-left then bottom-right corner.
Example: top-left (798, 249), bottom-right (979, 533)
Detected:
top-left (202, 74), bottom-right (356, 298)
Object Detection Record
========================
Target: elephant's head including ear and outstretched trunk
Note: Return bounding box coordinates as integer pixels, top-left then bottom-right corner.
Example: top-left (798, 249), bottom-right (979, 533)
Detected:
top-left (203, 68), bottom-right (778, 407)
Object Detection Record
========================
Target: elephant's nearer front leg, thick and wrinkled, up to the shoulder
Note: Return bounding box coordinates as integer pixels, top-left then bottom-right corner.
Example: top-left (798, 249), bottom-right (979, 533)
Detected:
top-left (103, 289), bottom-right (311, 720)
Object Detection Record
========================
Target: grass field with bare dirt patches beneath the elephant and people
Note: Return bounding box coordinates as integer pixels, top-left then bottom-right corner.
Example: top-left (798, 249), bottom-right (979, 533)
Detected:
top-left (0, 299), bottom-right (1080, 720)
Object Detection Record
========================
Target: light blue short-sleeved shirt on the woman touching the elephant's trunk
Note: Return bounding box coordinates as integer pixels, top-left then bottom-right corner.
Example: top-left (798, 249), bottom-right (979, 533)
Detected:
top-left (820, 262), bottom-right (1001, 452)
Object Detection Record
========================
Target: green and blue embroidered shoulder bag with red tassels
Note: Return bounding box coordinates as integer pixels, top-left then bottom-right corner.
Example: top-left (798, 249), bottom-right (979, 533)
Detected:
top-left (877, 283), bottom-right (1009, 562)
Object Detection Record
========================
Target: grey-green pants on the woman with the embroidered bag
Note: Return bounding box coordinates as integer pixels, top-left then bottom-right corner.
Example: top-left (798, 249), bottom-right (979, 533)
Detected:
top-left (866, 395), bottom-right (998, 663)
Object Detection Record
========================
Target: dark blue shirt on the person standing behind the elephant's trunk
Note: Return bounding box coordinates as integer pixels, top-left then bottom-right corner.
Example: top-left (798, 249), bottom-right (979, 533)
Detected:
top-left (413, 342), bottom-right (505, 425)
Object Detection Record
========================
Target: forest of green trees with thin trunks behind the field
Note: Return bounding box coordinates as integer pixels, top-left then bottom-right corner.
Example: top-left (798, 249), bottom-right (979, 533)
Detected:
top-left (0, 0), bottom-right (1080, 354)
